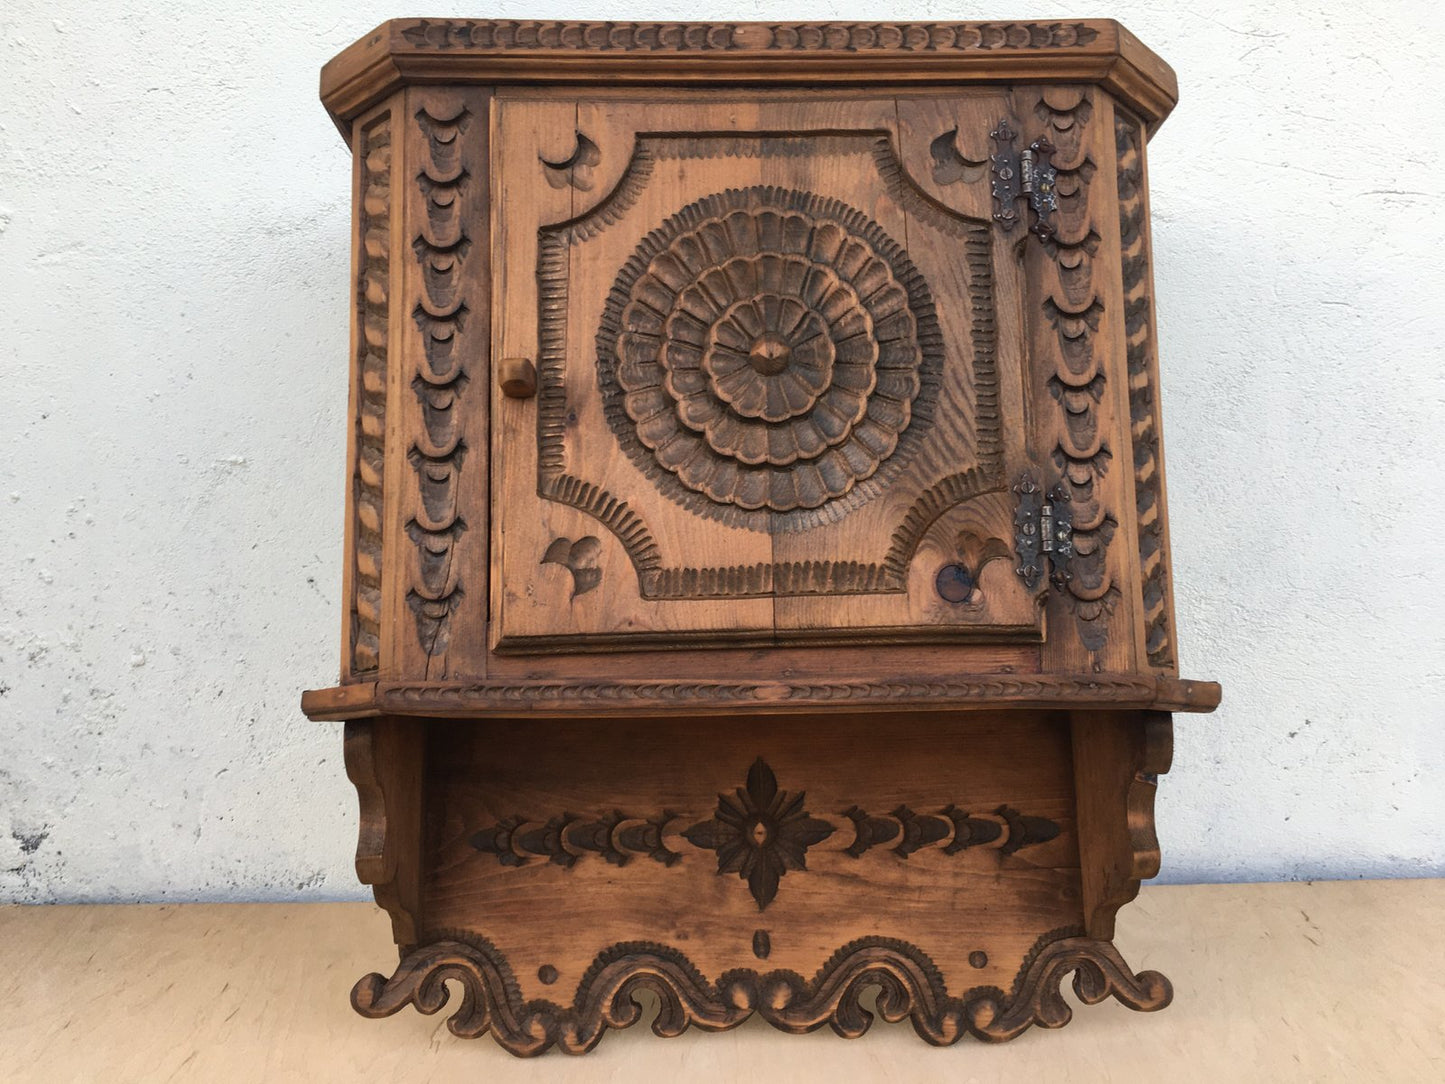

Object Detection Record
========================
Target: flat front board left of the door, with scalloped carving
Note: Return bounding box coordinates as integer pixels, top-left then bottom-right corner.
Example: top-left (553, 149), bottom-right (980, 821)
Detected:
top-left (386, 87), bottom-right (491, 681)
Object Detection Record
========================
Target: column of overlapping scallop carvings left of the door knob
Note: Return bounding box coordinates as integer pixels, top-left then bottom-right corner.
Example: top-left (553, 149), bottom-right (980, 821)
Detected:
top-left (406, 106), bottom-right (475, 658)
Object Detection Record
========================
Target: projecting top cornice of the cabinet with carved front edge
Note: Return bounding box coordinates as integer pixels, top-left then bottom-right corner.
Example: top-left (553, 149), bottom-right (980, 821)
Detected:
top-left (321, 19), bottom-right (1179, 133)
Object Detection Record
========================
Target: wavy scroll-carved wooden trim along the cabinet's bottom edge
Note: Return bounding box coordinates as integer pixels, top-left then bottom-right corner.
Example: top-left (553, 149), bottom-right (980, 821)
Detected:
top-left (351, 929), bottom-right (1173, 1057)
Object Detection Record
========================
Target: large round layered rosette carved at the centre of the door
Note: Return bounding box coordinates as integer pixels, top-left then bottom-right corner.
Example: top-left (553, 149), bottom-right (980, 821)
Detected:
top-left (598, 186), bottom-right (942, 530)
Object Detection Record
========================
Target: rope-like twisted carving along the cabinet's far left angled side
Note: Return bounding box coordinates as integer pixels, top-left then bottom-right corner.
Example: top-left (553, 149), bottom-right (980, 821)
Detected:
top-left (350, 113), bottom-right (392, 674)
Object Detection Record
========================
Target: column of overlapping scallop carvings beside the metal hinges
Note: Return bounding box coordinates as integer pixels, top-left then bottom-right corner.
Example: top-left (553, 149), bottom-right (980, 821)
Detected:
top-left (1035, 88), bottom-right (1120, 652)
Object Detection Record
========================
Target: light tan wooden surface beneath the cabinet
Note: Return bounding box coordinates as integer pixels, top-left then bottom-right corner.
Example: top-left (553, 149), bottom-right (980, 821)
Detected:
top-left (0, 880), bottom-right (1445, 1084)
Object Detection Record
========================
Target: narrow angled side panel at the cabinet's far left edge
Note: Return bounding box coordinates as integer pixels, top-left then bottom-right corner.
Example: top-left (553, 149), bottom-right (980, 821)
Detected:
top-left (341, 106), bottom-right (393, 681)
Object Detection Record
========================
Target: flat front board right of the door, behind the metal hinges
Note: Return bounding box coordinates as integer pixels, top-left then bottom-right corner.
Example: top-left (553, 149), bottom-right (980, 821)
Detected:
top-left (1016, 87), bottom-right (1133, 671)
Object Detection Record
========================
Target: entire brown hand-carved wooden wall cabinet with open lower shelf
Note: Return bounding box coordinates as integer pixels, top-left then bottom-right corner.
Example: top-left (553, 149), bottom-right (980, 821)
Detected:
top-left (303, 20), bottom-right (1220, 1054)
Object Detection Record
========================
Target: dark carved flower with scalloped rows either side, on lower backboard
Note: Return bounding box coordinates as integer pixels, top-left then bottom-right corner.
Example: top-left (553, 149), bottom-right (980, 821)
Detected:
top-left (468, 757), bottom-right (1059, 911)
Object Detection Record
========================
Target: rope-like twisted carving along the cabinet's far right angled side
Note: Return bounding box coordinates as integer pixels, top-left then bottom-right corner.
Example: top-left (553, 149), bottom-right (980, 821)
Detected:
top-left (1114, 113), bottom-right (1176, 671)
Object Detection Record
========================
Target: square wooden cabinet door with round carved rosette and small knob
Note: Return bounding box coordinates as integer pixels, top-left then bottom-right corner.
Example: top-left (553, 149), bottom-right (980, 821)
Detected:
top-left (491, 91), bottom-right (1040, 650)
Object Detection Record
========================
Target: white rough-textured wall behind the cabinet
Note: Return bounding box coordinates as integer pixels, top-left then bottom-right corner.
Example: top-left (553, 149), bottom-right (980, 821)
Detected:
top-left (0, 0), bottom-right (1445, 900)
